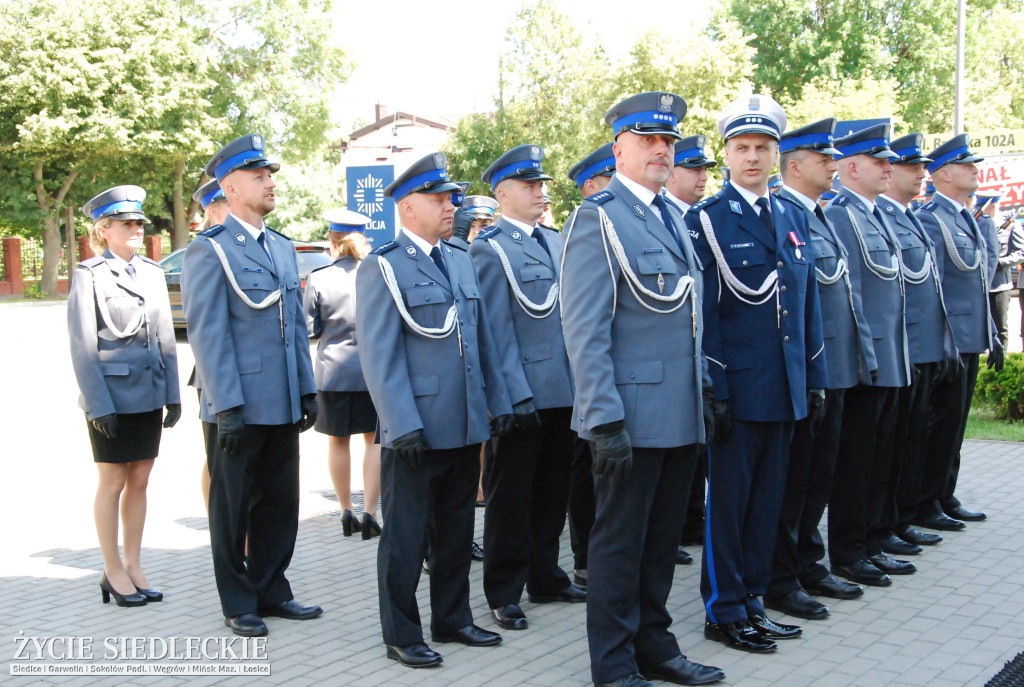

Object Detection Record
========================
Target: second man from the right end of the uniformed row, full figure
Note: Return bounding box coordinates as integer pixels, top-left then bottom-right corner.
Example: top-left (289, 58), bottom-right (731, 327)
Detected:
top-left (872, 133), bottom-right (956, 555)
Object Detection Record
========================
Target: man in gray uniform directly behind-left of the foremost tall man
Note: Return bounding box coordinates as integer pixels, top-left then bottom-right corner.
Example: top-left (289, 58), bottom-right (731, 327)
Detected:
top-left (469, 144), bottom-right (587, 630)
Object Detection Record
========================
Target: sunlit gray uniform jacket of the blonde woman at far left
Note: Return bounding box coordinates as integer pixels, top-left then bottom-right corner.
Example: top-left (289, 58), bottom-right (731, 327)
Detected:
top-left (68, 251), bottom-right (181, 420)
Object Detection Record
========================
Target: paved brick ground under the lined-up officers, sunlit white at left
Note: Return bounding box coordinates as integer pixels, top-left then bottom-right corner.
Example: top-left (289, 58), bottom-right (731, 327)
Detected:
top-left (0, 303), bottom-right (1024, 687)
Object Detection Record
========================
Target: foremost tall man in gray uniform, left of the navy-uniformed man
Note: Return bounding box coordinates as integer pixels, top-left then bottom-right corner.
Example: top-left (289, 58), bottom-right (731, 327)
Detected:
top-left (561, 92), bottom-right (725, 687)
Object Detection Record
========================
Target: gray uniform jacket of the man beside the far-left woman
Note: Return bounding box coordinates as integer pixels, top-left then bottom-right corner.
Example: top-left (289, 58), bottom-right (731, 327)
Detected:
top-left (181, 215), bottom-right (316, 425)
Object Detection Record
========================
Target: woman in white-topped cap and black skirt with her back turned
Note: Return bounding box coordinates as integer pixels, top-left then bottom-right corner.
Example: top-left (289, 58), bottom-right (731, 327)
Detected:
top-left (304, 209), bottom-right (381, 540)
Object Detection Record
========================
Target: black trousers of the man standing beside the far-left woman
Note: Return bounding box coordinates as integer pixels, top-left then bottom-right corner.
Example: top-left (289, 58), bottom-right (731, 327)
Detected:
top-left (204, 423), bottom-right (299, 617)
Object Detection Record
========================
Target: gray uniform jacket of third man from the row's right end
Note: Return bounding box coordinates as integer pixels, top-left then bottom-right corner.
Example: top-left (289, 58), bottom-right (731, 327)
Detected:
top-left (824, 188), bottom-right (910, 387)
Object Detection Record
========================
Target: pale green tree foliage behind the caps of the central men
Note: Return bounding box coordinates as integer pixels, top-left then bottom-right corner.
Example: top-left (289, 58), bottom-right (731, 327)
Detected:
top-left (446, 0), bottom-right (753, 223)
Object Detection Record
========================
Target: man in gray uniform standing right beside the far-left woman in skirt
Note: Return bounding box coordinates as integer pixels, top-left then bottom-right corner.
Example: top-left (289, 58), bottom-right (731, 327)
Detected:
top-left (181, 134), bottom-right (323, 637)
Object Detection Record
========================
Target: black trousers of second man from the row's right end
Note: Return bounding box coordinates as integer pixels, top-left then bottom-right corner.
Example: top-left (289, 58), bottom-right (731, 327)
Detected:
top-left (879, 362), bottom-right (939, 536)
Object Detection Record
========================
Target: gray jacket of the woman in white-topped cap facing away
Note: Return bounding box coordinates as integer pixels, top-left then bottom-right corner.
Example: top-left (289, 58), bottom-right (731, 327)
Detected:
top-left (302, 255), bottom-right (367, 391)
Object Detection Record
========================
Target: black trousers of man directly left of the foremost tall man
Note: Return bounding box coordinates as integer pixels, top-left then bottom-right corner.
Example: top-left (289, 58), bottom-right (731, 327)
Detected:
top-left (483, 407), bottom-right (577, 608)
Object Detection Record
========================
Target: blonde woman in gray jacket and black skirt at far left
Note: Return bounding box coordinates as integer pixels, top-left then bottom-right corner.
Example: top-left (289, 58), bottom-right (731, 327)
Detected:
top-left (68, 186), bottom-right (181, 606)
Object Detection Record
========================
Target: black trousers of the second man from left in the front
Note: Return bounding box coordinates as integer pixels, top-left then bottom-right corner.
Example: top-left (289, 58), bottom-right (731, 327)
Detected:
top-left (377, 444), bottom-right (480, 646)
